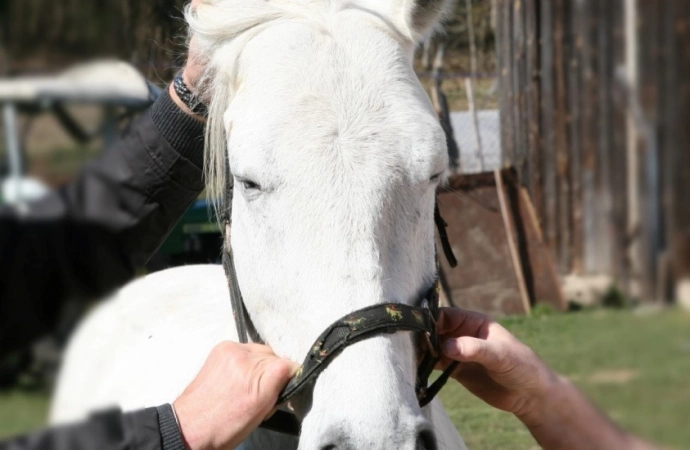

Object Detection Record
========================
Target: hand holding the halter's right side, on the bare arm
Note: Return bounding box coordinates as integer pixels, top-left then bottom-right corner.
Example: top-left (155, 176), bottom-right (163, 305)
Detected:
top-left (437, 308), bottom-right (559, 421)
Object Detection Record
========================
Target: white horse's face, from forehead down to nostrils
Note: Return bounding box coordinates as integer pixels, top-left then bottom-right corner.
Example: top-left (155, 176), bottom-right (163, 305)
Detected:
top-left (196, 1), bottom-right (447, 449)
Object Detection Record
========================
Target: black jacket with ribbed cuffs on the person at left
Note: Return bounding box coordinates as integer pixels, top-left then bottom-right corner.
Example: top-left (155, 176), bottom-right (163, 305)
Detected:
top-left (0, 90), bottom-right (204, 450)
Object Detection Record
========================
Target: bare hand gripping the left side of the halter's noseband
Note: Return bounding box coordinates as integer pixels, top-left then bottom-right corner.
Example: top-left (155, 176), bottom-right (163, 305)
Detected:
top-left (173, 342), bottom-right (299, 450)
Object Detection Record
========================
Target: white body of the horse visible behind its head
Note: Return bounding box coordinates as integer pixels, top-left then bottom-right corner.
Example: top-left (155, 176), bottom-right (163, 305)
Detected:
top-left (50, 266), bottom-right (463, 450)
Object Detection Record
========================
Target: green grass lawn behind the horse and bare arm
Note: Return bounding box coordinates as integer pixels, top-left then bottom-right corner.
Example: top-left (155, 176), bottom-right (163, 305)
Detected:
top-left (0, 310), bottom-right (690, 450)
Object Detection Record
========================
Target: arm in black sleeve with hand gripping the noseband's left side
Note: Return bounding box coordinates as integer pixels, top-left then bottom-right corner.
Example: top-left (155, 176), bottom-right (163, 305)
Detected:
top-left (0, 342), bottom-right (298, 450)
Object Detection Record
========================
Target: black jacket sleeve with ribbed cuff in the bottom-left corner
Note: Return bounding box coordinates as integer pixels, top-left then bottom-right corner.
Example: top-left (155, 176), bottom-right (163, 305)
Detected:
top-left (0, 405), bottom-right (185, 450)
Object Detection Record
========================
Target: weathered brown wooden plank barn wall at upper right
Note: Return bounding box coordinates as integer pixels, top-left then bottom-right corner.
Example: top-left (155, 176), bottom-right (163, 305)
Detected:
top-left (497, 0), bottom-right (690, 298)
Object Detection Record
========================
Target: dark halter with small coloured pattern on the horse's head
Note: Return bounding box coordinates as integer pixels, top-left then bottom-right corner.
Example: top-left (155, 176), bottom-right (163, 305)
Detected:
top-left (221, 173), bottom-right (458, 436)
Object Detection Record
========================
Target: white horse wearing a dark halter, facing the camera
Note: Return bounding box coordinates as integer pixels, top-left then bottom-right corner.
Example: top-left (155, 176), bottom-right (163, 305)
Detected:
top-left (51, 0), bottom-right (464, 450)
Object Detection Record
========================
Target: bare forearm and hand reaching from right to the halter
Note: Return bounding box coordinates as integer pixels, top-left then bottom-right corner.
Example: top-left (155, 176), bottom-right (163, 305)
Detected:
top-left (438, 308), bottom-right (656, 449)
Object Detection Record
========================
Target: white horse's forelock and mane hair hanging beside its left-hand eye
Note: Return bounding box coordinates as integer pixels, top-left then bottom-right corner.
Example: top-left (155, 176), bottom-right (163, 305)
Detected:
top-left (186, 0), bottom-right (422, 217)
